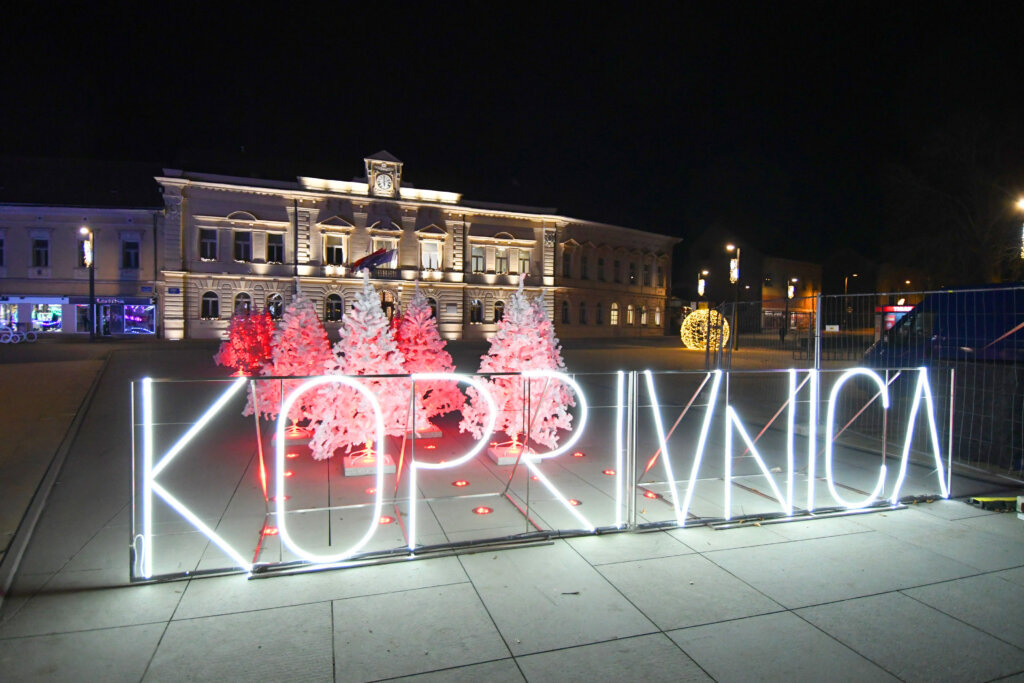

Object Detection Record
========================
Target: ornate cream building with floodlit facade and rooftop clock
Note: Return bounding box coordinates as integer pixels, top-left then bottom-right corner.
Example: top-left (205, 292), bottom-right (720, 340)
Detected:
top-left (157, 152), bottom-right (679, 340)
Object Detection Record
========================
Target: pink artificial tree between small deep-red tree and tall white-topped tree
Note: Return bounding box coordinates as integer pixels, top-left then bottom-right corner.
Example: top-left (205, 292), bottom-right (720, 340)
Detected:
top-left (243, 295), bottom-right (334, 422)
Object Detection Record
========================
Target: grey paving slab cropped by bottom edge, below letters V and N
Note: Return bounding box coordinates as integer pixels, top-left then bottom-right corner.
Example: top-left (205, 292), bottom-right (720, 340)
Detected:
top-left (668, 612), bottom-right (896, 682)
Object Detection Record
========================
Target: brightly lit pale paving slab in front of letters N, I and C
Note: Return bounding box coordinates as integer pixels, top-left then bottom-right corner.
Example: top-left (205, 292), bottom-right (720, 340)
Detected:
top-left (707, 533), bottom-right (977, 608)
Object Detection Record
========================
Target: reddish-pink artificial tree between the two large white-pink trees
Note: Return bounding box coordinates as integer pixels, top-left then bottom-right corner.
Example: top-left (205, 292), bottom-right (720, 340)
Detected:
top-left (395, 284), bottom-right (466, 432)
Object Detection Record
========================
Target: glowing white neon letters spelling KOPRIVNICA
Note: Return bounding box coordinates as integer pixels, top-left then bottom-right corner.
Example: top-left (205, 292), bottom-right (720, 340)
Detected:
top-left (132, 368), bottom-right (949, 581)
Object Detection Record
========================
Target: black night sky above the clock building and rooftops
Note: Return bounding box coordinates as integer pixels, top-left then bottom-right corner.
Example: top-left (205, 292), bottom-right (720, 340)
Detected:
top-left (0, 2), bottom-right (1024, 258)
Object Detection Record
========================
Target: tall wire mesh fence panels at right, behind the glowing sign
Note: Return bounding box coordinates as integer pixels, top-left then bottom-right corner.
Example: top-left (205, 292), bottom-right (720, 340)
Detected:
top-left (707, 285), bottom-right (1024, 474)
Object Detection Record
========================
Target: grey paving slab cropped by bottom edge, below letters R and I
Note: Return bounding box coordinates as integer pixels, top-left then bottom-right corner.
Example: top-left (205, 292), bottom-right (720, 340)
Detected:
top-left (516, 634), bottom-right (712, 682)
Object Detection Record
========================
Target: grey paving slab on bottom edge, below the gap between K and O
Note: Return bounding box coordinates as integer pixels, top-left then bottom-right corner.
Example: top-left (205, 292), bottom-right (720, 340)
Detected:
top-left (143, 602), bottom-right (333, 681)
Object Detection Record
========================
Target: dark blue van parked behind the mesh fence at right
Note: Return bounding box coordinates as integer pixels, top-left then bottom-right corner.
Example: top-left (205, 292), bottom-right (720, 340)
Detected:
top-left (864, 284), bottom-right (1024, 368)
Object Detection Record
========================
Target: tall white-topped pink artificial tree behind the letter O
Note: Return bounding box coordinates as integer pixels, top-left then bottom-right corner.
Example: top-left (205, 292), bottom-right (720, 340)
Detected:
top-left (309, 272), bottom-right (410, 460)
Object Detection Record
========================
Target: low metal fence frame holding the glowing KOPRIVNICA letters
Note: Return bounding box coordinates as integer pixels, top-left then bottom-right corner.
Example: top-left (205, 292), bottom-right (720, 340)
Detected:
top-left (130, 368), bottom-right (962, 581)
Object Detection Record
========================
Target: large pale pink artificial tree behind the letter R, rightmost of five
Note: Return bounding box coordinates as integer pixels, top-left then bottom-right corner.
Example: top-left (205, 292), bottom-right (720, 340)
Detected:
top-left (459, 278), bottom-right (575, 447)
